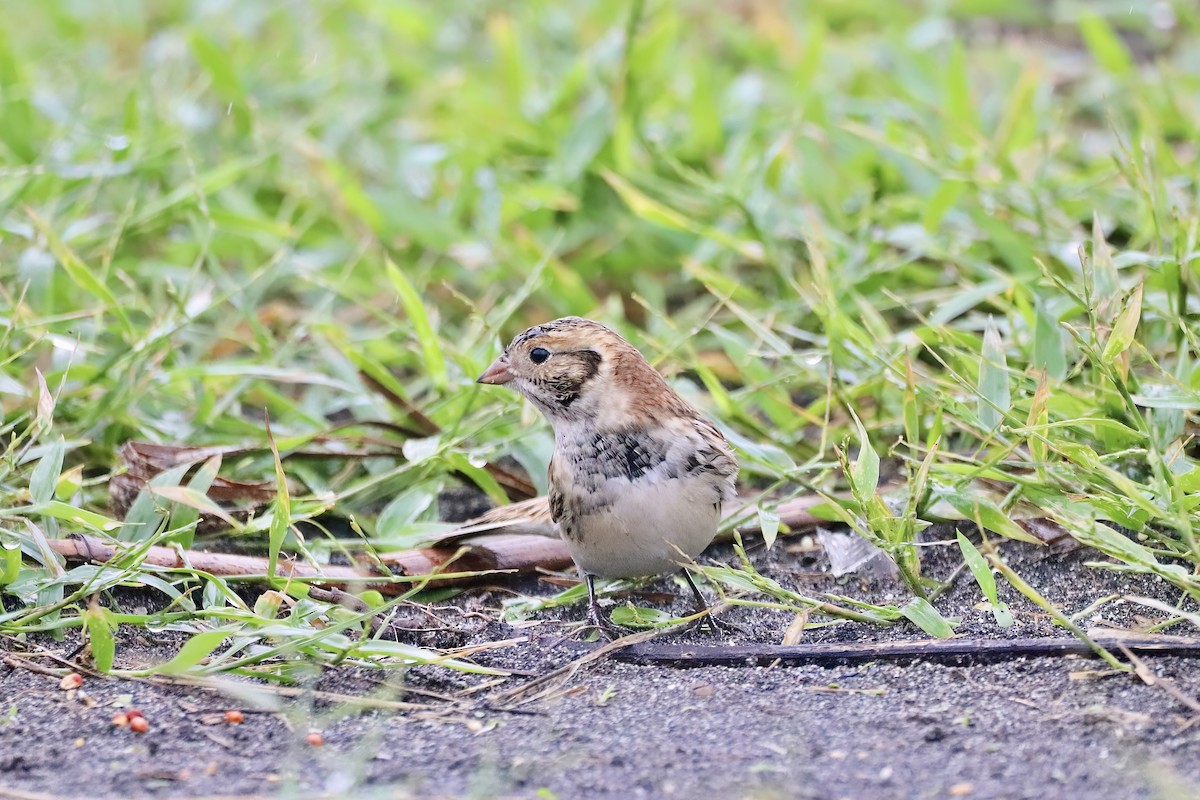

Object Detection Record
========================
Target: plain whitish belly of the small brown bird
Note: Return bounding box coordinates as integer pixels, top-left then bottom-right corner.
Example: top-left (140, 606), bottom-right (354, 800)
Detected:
top-left (564, 479), bottom-right (721, 578)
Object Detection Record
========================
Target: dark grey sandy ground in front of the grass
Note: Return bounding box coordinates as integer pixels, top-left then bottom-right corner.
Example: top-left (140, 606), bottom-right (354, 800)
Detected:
top-left (0, 527), bottom-right (1200, 800)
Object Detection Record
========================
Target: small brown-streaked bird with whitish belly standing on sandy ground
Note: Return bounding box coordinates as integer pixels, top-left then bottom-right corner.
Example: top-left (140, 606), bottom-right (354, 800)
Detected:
top-left (479, 317), bottom-right (738, 631)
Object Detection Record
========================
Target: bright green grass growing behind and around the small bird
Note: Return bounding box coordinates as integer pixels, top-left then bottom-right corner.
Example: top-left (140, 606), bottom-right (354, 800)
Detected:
top-left (0, 0), bottom-right (1200, 678)
